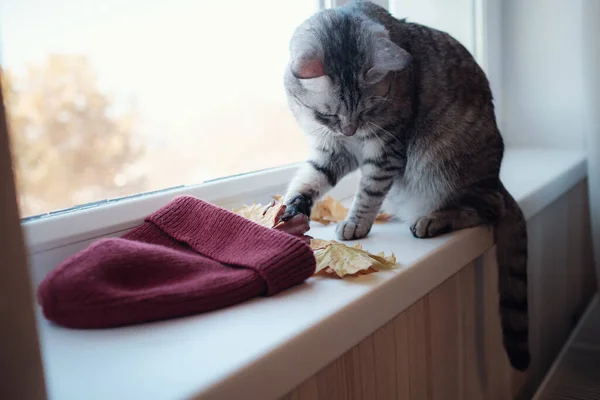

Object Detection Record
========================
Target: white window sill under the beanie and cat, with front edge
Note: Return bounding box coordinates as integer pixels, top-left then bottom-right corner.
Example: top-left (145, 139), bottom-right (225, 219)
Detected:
top-left (38, 149), bottom-right (587, 400)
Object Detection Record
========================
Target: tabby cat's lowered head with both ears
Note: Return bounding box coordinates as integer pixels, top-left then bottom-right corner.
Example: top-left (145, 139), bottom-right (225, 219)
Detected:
top-left (285, 9), bottom-right (411, 136)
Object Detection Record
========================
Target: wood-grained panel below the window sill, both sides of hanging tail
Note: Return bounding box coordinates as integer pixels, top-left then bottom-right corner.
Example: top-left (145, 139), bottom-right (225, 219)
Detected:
top-left (283, 181), bottom-right (596, 400)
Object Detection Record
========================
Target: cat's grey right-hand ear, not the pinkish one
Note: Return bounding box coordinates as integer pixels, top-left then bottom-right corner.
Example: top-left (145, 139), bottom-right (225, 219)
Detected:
top-left (365, 37), bottom-right (412, 84)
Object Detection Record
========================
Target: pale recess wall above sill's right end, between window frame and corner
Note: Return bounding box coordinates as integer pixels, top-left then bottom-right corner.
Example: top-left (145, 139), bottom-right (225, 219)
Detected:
top-left (500, 0), bottom-right (590, 149)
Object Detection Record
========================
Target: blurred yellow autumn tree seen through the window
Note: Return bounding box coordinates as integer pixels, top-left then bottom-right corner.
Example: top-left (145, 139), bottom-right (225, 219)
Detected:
top-left (2, 55), bottom-right (147, 215)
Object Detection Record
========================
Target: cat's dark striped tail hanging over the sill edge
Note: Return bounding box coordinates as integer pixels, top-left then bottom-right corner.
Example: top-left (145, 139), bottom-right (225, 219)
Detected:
top-left (494, 184), bottom-right (531, 371)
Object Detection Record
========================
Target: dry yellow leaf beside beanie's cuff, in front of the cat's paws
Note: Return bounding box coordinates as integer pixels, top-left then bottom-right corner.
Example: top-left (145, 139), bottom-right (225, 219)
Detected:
top-left (311, 239), bottom-right (396, 278)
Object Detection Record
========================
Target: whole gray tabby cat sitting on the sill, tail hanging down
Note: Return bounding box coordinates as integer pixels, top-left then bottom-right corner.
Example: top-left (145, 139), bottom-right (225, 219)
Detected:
top-left (284, 2), bottom-right (530, 370)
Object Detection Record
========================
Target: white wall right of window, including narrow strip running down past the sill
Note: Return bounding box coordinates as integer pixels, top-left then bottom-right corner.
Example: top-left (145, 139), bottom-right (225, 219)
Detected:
top-left (500, 0), bottom-right (600, 283)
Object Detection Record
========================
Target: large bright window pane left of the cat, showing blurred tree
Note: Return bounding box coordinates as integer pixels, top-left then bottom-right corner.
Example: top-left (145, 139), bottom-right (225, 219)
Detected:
top-left (0, 0), bottom-right (319, 216)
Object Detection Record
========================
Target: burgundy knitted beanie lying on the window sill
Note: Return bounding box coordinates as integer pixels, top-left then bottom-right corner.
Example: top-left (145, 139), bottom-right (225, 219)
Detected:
top-left (38, 197), bottom-right (316, 328)
